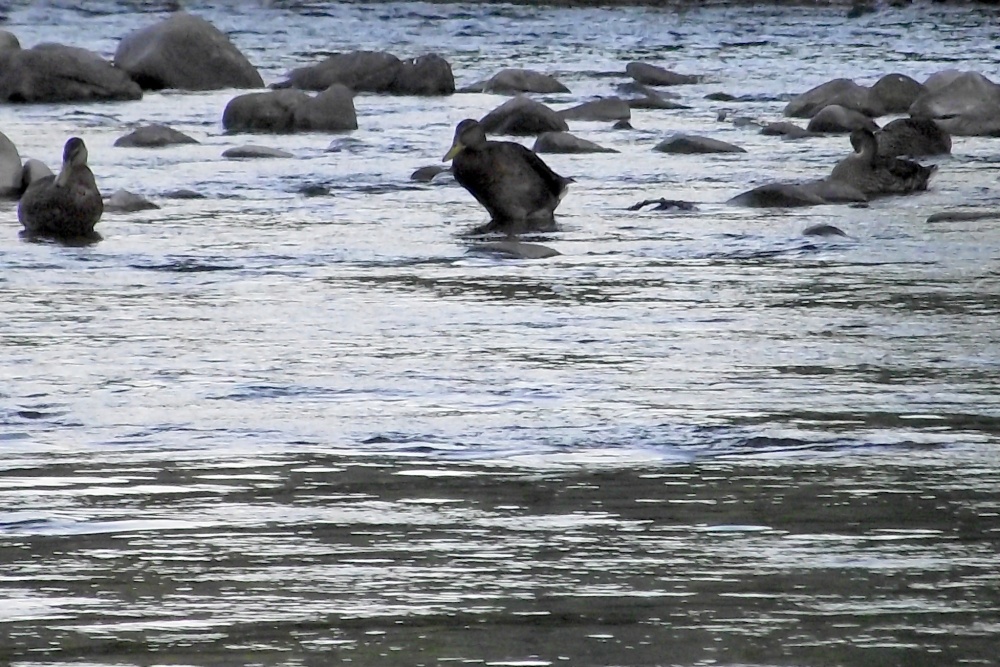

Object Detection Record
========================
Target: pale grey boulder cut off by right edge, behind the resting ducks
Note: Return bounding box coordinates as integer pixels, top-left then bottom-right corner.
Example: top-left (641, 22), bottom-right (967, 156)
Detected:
top-left (910, 70), bottom-right (1000, 136)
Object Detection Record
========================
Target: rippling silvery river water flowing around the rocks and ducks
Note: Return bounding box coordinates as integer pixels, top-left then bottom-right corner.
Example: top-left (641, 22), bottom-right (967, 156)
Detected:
top-left (0, 1), bottom-right (1000, 667)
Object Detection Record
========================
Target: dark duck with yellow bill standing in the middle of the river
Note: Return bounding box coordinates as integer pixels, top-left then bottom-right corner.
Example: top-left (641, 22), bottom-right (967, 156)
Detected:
top-left (444, 119), bottom-right (573, 236)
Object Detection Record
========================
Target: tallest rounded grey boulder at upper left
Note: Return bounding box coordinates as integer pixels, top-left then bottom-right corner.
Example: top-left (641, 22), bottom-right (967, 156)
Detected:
top-left (114, 12), bottom-right (264, 90)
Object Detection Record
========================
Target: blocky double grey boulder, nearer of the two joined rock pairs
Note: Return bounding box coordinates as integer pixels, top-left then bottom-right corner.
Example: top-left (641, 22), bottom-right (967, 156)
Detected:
top-left (222, 84), bottom-right (358, 133)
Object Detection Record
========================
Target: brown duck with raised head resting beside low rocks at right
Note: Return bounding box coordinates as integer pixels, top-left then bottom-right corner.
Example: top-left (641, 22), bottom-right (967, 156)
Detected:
top-left (830, 128), bottom-right (937, 196)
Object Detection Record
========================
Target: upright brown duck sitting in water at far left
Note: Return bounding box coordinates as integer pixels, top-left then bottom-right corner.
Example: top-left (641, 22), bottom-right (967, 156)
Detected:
top-left (17, 137), bottom-right (104, 238)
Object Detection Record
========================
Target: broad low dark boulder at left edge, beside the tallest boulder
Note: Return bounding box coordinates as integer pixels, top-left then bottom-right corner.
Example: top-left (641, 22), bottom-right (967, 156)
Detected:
top-left (0, 44), bottom-right (142, 103)
